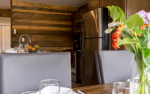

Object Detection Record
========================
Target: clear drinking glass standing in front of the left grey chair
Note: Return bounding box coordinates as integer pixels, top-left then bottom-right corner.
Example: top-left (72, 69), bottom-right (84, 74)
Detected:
top-left (39, 79), bottom-right (60, 94)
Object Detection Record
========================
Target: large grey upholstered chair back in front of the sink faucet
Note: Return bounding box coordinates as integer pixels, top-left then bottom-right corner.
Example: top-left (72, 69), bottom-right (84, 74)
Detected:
top-left (0, 52), bottom-right (71, 94)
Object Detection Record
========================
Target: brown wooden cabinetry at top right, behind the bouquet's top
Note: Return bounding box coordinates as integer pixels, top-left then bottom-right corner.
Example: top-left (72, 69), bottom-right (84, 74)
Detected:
top-left (99, 0), bottom-right (150, 18)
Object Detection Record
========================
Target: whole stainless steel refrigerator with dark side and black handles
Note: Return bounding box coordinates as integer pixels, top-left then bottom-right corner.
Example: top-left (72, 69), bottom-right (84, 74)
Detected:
top-left (81, 8), bottom-right (109, 86)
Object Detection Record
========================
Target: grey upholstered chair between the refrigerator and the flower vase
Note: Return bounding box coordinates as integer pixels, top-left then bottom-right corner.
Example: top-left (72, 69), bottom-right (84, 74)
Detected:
top-left (95, 50), bottom-right (133, 84)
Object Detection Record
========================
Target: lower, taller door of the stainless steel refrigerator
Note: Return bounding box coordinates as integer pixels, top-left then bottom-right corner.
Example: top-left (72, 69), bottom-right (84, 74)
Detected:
top-left (82, 38), bottom-right (102, 86)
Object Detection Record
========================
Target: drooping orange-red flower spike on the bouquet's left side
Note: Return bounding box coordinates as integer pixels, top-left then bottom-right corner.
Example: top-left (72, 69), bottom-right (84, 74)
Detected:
top-left (112, 24), bottom-right (125, 50)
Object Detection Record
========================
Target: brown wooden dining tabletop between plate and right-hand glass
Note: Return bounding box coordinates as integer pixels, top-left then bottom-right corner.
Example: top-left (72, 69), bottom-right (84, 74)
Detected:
top-left (73, 84), bottom-right (113, 94)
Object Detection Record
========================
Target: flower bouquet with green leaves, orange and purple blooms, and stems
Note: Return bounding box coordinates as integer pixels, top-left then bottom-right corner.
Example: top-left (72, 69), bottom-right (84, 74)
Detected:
top-left (105, 6), bottom-right (150, 94)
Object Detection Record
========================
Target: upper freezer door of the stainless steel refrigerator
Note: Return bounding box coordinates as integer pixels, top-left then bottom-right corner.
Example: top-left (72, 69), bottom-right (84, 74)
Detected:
top-left (82, 8), bottom-right (102, 38)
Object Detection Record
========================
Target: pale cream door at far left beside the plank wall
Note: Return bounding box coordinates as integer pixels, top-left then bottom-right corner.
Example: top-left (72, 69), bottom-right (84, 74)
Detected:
top-left (2, 26), bottom-right (11, 50)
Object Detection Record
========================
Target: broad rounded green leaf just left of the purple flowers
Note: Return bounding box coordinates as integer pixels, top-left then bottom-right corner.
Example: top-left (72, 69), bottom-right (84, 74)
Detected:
top-left (127, 14), bottom-right (144, 29)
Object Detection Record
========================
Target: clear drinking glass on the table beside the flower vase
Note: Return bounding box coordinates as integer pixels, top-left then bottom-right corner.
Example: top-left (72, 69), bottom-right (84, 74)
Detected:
top-left (112, 82), bottom-right (135, 94)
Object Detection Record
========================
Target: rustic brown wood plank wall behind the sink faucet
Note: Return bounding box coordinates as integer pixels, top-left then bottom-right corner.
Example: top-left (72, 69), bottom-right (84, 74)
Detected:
top-left (11, 1), bottom-right (77, 51)
